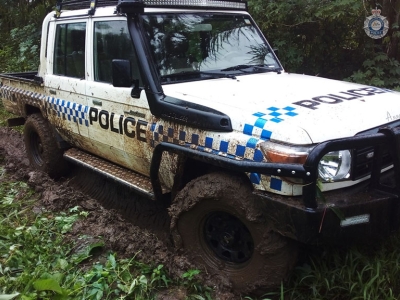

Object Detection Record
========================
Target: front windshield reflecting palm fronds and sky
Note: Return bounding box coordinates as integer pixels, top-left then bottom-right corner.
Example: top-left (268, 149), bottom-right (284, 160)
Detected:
top-left (143, 13), bottom-right (281, 82)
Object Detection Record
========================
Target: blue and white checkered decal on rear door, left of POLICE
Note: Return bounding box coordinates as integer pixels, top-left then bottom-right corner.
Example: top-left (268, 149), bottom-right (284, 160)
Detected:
top-left (46, 97), bottom-right (89, 127)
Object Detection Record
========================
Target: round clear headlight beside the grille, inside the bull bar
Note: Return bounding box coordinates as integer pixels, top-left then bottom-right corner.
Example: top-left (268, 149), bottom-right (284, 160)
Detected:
top-left (318, 150), bottom-right (351, 182)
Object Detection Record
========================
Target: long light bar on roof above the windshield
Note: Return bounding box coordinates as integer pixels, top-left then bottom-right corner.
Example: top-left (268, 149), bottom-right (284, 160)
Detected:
top-left (144, 0), bottom-right (247, 10)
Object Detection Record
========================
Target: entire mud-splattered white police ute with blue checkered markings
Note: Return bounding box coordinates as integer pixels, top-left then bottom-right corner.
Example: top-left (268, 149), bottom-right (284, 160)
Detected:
top-left (0, 0), bottom-right (400, 292)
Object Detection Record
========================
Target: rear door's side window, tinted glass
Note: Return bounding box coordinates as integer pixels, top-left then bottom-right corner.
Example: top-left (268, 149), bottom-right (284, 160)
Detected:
top-left (53, 23), bottom-right (86, 78)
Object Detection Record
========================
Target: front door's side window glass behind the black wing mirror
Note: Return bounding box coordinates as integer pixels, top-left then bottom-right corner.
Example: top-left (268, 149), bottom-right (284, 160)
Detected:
top-left (93, 20), bottom-right (142, 85)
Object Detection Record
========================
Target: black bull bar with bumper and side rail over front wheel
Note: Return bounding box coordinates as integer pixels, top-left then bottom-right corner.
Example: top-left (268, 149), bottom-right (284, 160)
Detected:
top-left (151, 127), bottom-right (400, 244)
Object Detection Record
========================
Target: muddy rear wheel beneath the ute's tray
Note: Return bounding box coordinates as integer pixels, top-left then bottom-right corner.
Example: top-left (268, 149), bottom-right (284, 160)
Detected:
top-left (24, 114), bottom-right (67, 178)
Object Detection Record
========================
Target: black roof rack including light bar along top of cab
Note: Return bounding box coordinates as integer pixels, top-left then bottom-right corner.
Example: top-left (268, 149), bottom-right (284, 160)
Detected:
top-left (56, 0), bottom-right (248, 15)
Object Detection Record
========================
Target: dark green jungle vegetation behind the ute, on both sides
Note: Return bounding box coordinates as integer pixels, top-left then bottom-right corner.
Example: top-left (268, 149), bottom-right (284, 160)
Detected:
top-left (0, 0), bottom-right (400, 89)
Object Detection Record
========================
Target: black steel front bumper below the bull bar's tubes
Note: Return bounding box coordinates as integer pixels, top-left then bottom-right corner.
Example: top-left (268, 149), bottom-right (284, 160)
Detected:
top-left (254, 171), bottom-right (400, 245)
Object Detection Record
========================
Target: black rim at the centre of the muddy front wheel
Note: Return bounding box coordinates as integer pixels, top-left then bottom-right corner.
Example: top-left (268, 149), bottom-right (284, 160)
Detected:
top-left (203, 212), bottom-right (254, 264)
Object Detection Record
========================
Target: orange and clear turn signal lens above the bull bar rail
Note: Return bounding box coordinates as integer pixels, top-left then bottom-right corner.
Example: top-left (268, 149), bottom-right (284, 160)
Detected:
top-left (260, 141), bottom-right (312, 164)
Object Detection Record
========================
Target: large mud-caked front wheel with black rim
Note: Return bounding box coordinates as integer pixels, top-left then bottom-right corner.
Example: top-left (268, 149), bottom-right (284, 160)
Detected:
top-left (169, 173), bottom-right (297, 294)
